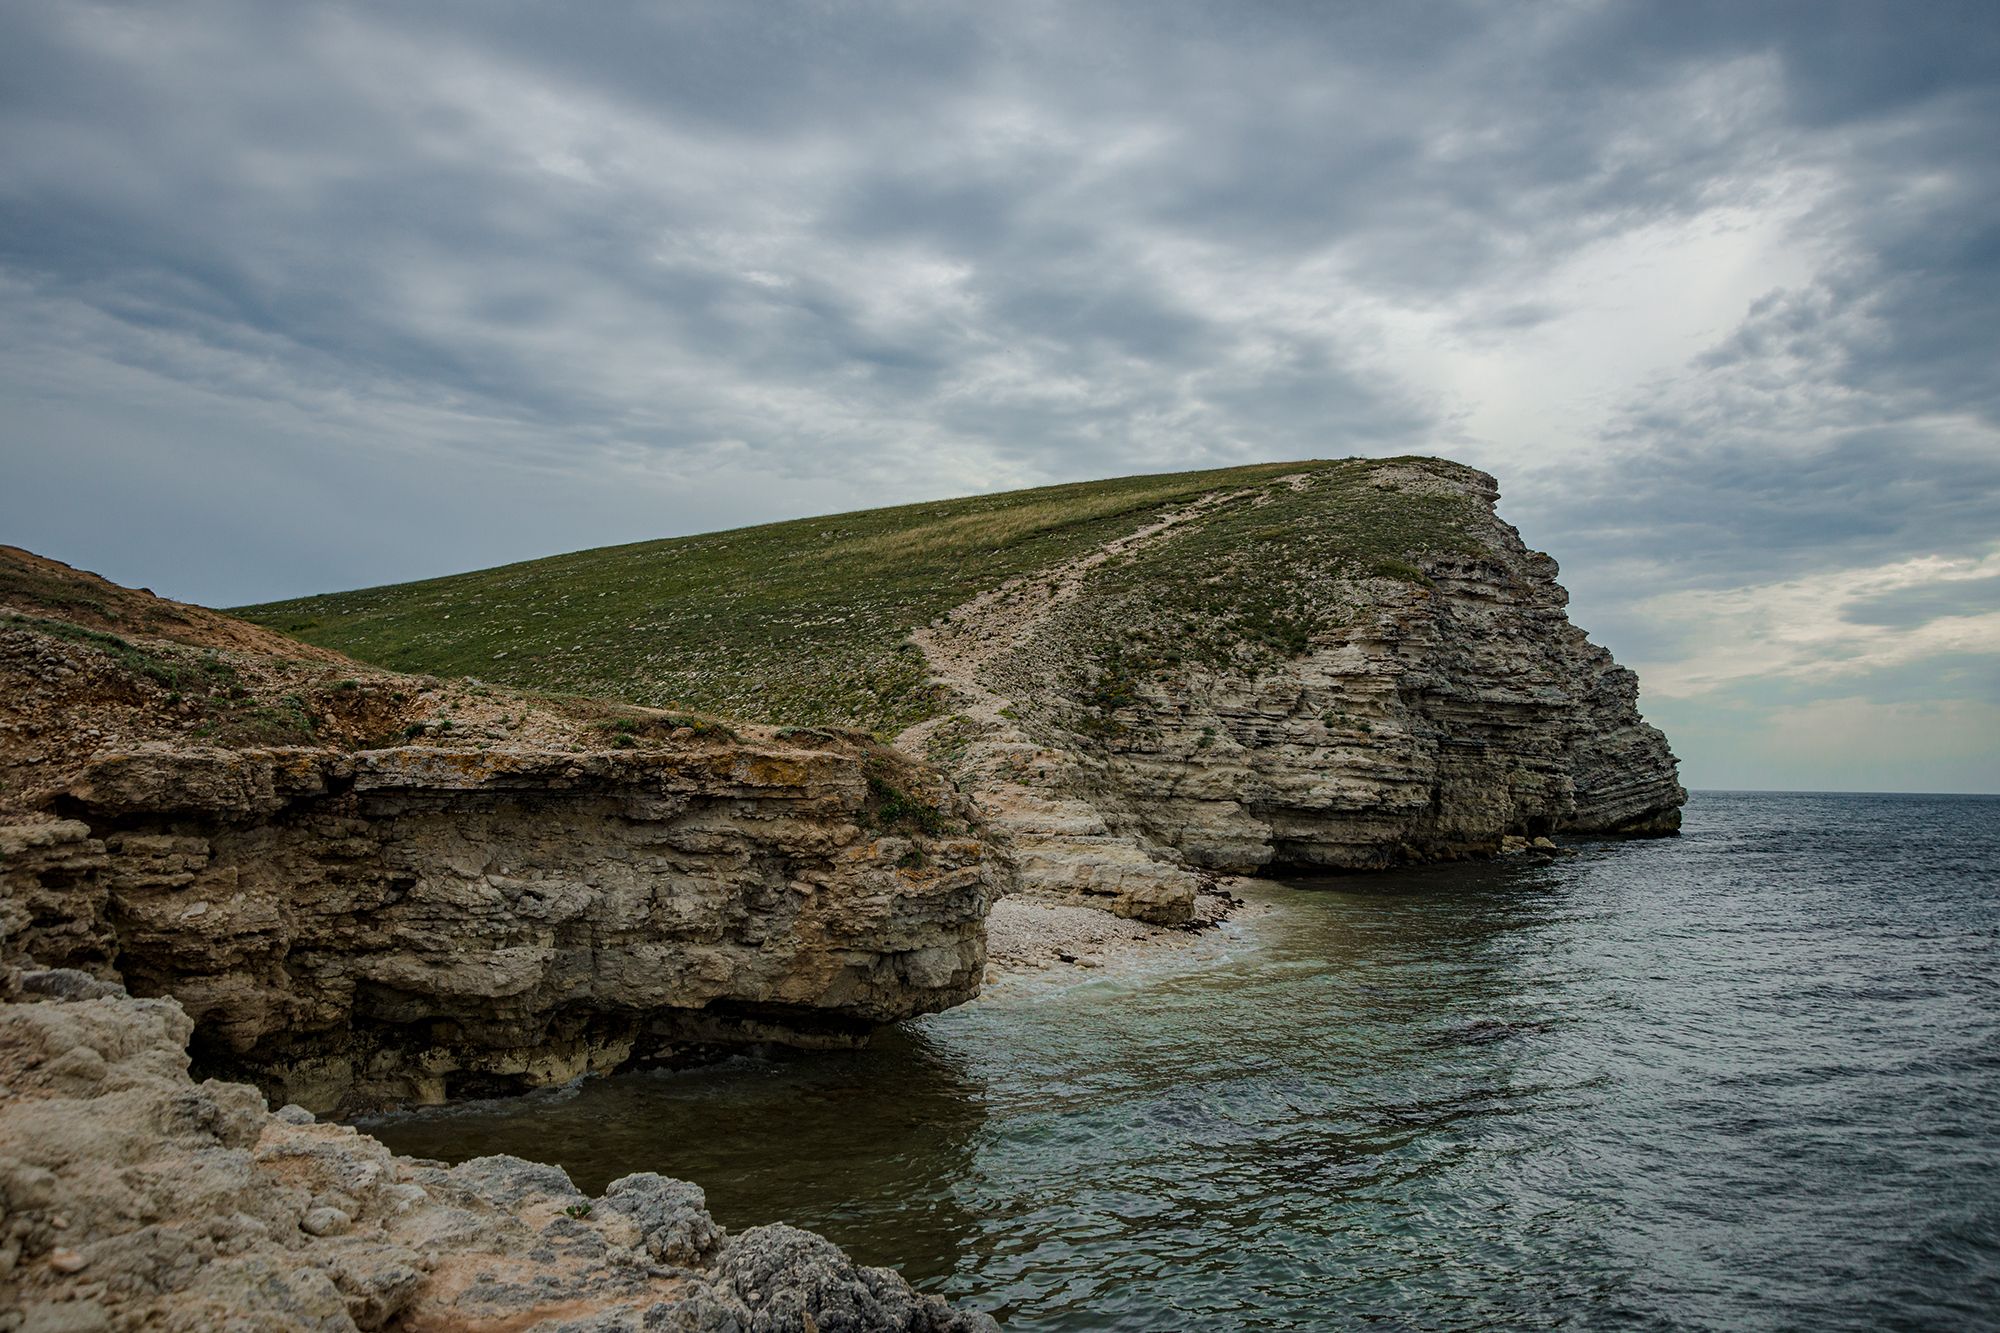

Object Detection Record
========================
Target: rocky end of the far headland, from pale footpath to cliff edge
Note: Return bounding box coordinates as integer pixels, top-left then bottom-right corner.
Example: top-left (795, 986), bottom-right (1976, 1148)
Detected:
top-left (908, 460), bottom-right (1686, 921)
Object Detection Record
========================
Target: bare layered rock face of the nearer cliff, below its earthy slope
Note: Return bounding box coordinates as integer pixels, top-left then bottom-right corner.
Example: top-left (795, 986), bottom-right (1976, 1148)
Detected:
top-left (0, 747), bottom-right (994, 1111)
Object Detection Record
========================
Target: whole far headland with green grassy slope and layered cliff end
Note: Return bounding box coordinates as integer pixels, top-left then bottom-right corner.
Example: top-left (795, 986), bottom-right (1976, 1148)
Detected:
top-left (248, 458), bottom-right (1686, 923)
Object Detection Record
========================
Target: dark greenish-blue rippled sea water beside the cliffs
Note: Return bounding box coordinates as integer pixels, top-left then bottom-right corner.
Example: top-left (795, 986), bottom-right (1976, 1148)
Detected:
top-left (370, 793), bottom-right (2000, 1329)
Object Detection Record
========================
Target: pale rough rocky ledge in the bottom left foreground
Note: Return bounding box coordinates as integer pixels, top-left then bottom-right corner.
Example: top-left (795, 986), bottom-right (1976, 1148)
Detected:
top-left (0, 969), bottom-right (998, 1333)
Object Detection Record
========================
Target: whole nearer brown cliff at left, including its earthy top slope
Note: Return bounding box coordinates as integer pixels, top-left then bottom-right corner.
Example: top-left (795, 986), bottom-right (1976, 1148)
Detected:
top-left (0, 558), bottom-right (1008, 1113)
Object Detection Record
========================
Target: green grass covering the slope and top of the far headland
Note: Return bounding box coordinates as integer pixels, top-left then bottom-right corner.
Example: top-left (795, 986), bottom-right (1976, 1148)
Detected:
top-left (236, 458), bottom-right (1470, 735)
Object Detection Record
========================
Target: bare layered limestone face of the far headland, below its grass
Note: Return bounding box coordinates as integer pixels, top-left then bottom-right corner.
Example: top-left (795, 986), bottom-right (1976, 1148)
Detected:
top-left (1050, 560), bottom-right (1684, 873)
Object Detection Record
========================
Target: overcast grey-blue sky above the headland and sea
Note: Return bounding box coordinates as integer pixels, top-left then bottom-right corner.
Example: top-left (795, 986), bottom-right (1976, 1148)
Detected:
top-left (0, 0), bottom-right (2000, 791)
